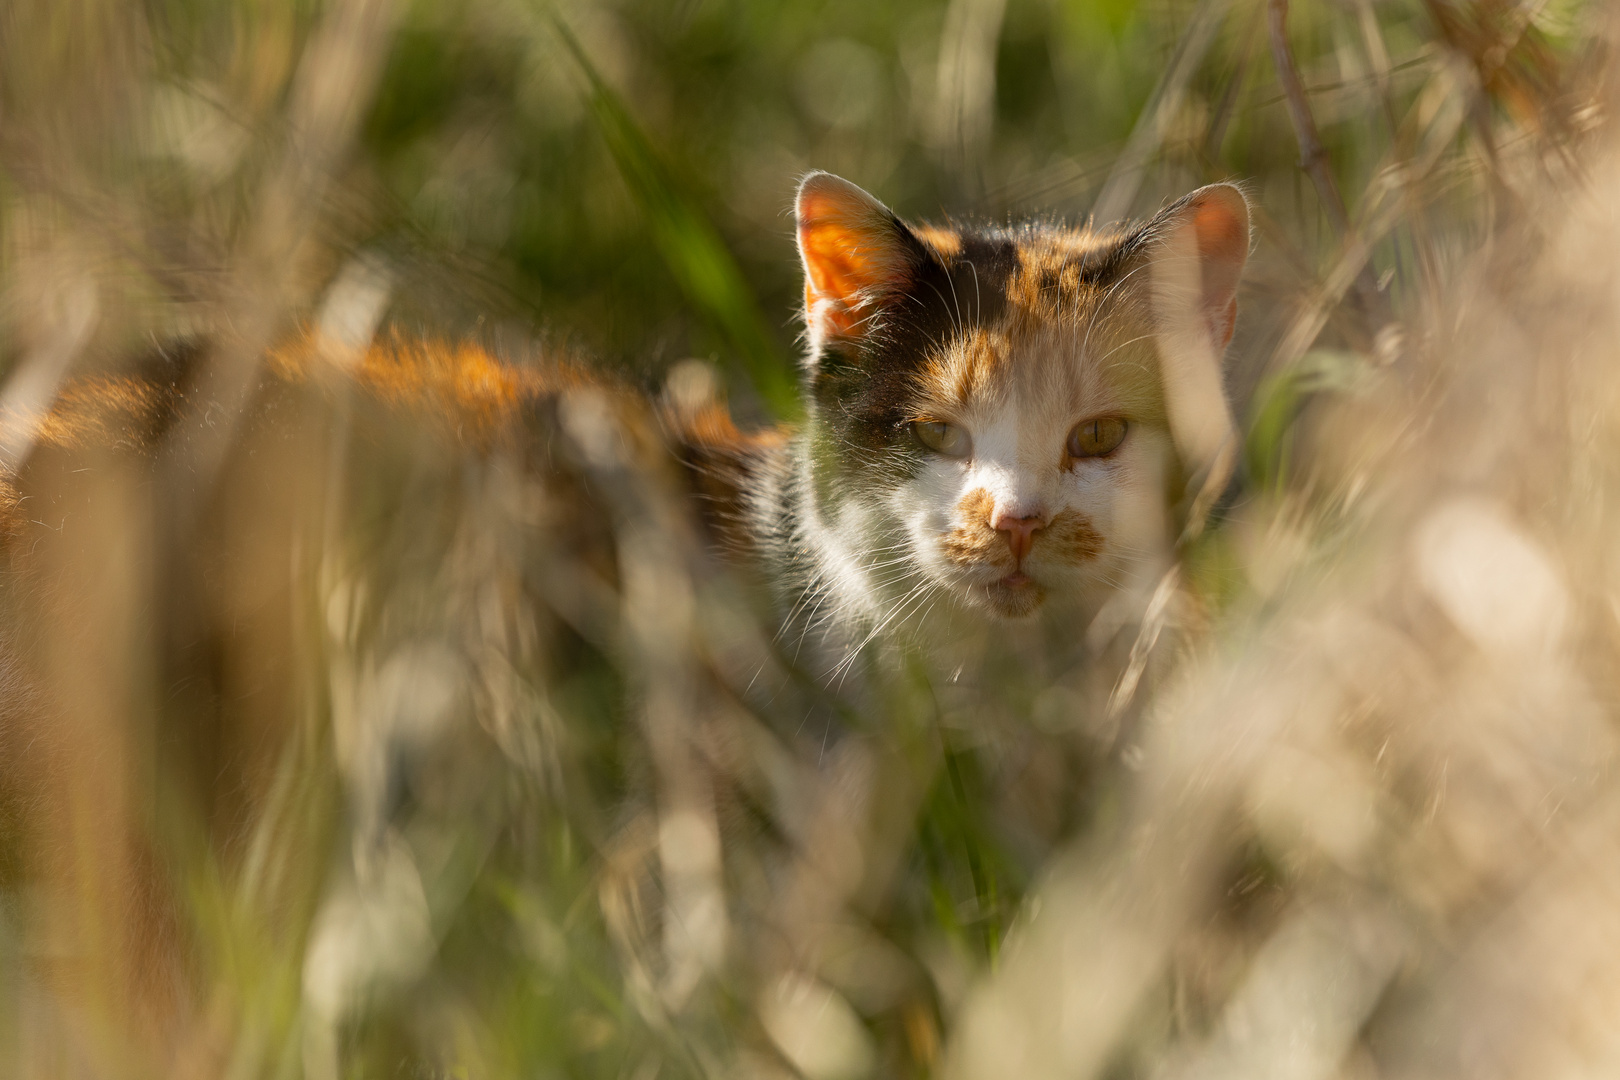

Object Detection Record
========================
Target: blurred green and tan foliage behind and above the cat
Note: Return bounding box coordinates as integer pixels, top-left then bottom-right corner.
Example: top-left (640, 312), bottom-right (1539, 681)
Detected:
top-left (6, 0), bottom-right (1589, 410)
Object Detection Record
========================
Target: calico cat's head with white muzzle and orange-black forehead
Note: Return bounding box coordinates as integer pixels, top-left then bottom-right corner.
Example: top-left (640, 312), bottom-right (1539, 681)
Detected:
top-left (797, 173), bottom-right (1249, 619)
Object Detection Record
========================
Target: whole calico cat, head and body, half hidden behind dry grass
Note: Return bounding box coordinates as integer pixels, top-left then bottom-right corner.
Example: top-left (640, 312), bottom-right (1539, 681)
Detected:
top-left (0, 175), bottom-right (1247, 1075)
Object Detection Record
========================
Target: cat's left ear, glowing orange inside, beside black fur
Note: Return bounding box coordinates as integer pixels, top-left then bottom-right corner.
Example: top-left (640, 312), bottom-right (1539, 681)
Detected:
top-left (795, 173), bottom-right (922, 342)
